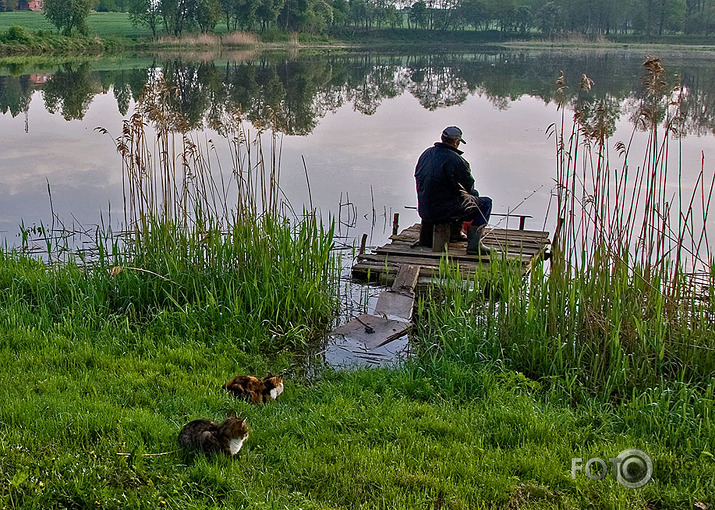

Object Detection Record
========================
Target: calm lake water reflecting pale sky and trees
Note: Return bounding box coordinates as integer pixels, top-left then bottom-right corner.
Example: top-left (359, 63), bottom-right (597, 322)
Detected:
top-left (0, 50), bottom-right (715, 251)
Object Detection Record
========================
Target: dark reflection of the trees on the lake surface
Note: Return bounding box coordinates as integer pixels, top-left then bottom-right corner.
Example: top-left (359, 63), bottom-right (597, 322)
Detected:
top-left (0, 52), bottom-right (715, 135)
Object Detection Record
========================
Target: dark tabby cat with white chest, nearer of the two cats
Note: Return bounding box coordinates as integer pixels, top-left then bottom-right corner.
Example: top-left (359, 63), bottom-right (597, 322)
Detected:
top-left (179, 412), bottom-right (248, 457)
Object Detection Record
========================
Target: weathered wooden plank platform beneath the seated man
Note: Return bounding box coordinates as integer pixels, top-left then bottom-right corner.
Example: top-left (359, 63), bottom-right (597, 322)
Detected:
top-left (352, 223), bottom-right (550, 284)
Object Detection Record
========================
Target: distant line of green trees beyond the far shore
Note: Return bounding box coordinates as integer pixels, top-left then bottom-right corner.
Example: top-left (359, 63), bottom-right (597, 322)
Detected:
top-left (0, 0), bottom-right (715, 37)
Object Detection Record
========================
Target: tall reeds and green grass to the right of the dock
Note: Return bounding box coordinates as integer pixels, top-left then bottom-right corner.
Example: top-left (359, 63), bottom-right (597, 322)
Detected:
top-left (422, 59), bottom-right (715, 404)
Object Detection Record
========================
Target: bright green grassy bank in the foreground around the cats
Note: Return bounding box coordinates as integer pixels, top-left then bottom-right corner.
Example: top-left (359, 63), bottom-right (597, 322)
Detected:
top-left (0, 249), bottom-right (715, 509)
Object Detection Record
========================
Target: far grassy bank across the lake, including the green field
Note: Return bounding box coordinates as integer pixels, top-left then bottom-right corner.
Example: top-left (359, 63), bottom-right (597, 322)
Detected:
top-left (0, 11), bottom-right (715, 56)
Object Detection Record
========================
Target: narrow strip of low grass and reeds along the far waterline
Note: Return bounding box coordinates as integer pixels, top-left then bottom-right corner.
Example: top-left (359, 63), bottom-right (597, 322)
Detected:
top-left (0, 24), bottom-right (715, 58)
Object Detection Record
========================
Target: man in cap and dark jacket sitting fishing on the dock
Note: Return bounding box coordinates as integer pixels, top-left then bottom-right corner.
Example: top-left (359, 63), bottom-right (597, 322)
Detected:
top-left (415, 126), bottom-right (492, 255)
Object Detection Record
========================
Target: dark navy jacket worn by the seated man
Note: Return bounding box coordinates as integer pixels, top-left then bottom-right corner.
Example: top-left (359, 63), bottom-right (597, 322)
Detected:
top-left (415, 142), bottom-right (474, 223)
